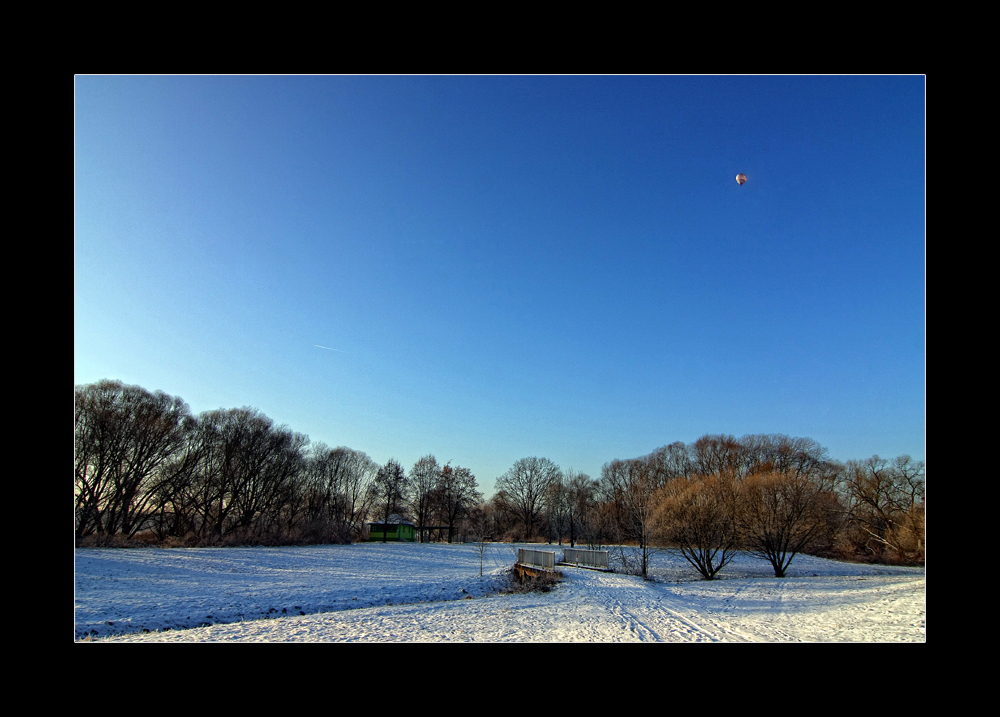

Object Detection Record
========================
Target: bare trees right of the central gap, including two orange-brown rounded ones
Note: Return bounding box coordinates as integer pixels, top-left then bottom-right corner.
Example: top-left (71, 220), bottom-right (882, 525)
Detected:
top-left (485, 434), bottom-right (925, 579)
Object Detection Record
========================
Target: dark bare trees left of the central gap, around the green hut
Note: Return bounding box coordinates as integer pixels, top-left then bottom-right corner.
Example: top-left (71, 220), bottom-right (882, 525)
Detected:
top-left (74, 380), bottom-right (482, 545)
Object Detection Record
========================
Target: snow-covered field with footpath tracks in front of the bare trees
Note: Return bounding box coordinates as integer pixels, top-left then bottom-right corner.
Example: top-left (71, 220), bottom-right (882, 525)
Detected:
top-left (75, 543), bottom-right (926, 642)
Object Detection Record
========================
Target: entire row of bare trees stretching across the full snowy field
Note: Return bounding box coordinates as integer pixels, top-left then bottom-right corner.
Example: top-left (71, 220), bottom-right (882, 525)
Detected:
top-left (74, 380), bottom-right (925, 579)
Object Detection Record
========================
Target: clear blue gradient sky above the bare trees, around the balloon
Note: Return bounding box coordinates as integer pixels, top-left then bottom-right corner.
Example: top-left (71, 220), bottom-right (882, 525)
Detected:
top-left (74, 76), bottom-right (925, 495)
